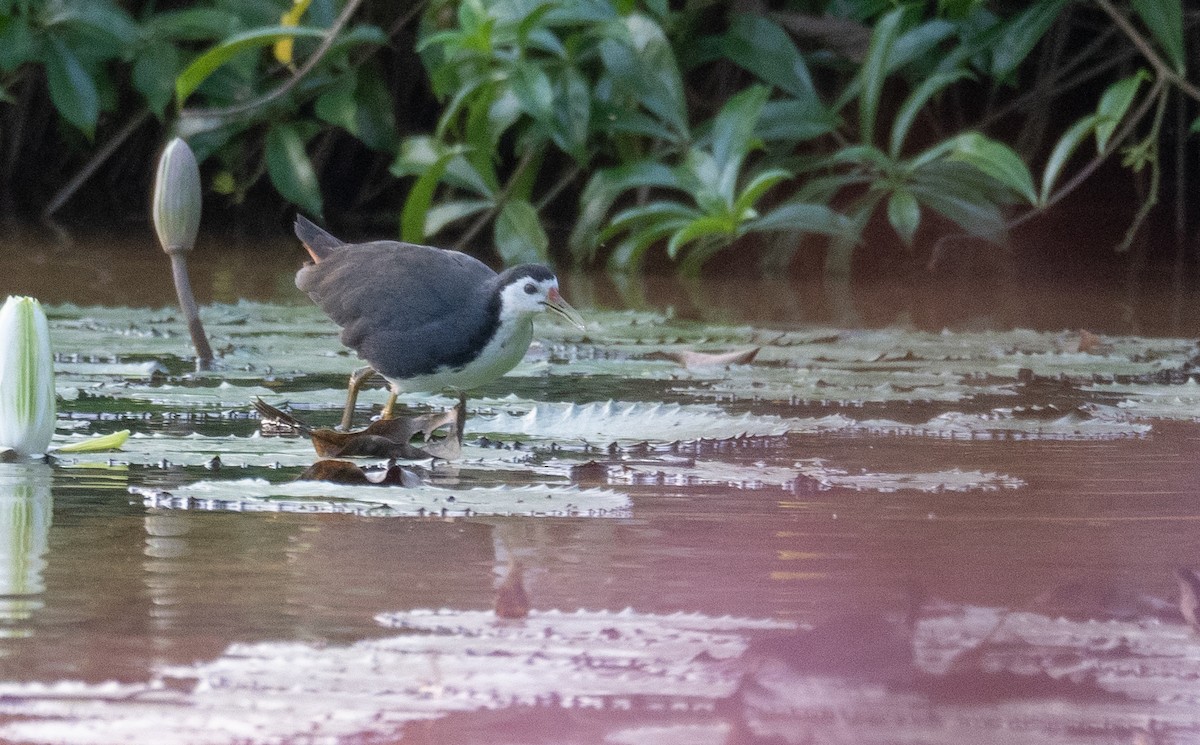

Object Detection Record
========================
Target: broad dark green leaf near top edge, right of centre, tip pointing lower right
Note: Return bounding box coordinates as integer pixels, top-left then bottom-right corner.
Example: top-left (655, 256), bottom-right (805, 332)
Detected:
top-left (720, 13), bottom-right (821, 100)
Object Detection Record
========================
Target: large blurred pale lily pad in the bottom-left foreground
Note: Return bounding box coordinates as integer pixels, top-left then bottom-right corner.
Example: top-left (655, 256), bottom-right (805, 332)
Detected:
top-left (0, 609), bottom-right (796, 745)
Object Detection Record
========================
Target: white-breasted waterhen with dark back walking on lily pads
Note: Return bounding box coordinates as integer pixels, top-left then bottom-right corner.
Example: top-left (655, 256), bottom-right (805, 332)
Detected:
top-left (295, 215), bottom-right (583, 429)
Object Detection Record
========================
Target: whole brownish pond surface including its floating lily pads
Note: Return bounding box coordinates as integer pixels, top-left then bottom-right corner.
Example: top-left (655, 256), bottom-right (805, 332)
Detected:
top-left (0, 235), bottom-right (1200, 743)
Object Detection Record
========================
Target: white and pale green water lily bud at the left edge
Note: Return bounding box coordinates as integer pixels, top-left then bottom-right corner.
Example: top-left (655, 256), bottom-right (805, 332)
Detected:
top-left (0, 296), bottom-right (55, 455)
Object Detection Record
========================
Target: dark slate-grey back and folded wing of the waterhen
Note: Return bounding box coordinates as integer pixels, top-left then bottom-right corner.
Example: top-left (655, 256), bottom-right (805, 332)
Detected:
top-left (296, 241), bottom-right (496, 378)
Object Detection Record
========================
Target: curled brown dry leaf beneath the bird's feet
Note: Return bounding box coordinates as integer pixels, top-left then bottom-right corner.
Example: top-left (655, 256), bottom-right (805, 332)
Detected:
top-left (254, 398), bottom-right (462, 461)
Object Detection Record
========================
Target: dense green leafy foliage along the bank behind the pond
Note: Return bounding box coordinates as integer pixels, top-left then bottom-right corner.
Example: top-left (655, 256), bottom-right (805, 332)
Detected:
top-left (0, 0), bottom-right (1200, 274)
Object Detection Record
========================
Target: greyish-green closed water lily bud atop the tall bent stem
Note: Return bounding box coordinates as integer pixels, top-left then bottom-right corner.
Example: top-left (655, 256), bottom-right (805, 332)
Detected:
top-left (152, 137), bottom-right (202, 253)
